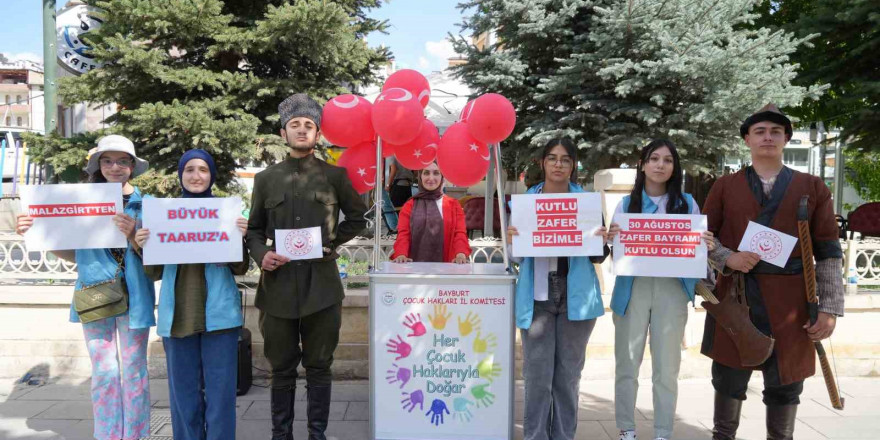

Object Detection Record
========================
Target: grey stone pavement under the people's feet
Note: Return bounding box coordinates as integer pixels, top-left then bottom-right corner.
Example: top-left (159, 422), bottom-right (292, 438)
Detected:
top-left (0, 375), bottom-right (880, 440)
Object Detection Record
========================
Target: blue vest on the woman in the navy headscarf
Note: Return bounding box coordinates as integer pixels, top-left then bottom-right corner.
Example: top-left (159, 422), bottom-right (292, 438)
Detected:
top-left (156, 263), bottom-right (242, 337)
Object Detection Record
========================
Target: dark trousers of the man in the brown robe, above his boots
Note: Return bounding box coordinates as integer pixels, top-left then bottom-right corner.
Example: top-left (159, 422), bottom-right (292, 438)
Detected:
top-left (712, 353), bottom-right (804, 406)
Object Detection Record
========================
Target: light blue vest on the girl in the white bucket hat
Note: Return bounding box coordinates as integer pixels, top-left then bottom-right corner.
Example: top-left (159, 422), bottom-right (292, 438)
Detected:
top-left (70, 188), bottom-right (156, 329)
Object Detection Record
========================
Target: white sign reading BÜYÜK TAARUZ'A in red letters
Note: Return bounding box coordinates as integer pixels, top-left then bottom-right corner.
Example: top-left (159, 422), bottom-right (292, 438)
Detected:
top-left (143, 197), bottom-right (243, 265)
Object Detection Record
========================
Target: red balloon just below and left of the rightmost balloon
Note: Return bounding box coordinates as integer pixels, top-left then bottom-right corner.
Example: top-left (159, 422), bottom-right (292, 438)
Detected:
top-left (437, 122), bottom-right (489, 186)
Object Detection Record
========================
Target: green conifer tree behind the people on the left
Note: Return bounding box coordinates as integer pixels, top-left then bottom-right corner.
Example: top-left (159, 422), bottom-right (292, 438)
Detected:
top-left (29, 0), bottom-right (389, 194)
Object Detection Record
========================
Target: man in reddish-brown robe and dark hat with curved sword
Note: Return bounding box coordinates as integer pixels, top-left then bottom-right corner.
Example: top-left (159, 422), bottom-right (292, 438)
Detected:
top-left (701, 104), bottom-right (843, 440)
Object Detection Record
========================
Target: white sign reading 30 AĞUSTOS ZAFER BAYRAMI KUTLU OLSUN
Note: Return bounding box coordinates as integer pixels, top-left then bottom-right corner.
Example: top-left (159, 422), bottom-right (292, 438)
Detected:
top-left (614, 214), bottom-right (707, 278)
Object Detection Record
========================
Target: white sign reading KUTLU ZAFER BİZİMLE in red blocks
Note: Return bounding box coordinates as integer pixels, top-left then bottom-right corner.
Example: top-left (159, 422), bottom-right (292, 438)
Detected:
top-left (510, 193), bottom-right (604, 257)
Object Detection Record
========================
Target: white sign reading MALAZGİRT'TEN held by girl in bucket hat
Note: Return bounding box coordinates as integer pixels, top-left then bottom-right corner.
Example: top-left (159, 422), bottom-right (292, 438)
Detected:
top-left (21, 183), bottom-right (127, 251)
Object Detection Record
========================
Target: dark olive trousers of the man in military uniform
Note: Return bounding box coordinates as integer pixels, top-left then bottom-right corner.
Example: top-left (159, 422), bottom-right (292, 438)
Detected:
top-left (260, 303), bottom-right (342, 388)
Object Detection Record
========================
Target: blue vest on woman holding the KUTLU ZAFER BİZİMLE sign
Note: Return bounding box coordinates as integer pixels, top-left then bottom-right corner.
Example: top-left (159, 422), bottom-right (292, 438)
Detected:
top-left (515, 183), bottom-right (605, 329)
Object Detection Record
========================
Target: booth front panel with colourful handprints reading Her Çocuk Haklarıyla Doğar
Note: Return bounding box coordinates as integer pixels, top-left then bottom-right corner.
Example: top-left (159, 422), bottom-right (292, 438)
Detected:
top-left (371, 279), bottom-right (513, 440)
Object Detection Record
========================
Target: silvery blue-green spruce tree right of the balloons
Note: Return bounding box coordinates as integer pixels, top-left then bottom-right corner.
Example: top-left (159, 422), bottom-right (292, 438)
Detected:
top-left (457, 0), bottom-right (823, 175)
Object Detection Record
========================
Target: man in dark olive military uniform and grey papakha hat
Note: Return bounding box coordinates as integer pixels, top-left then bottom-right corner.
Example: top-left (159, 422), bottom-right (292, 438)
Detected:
top-left (246, 93), bottom-right (367, 440)
